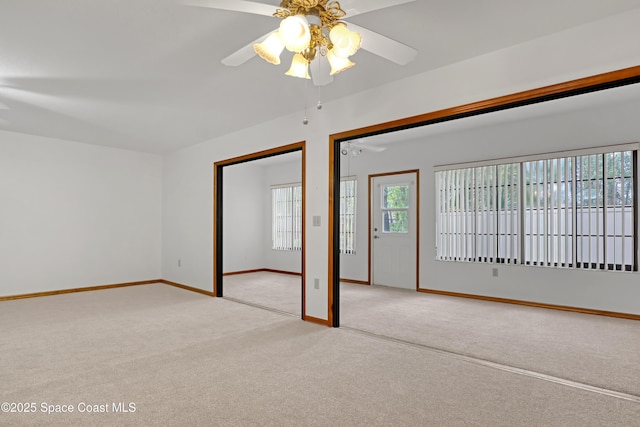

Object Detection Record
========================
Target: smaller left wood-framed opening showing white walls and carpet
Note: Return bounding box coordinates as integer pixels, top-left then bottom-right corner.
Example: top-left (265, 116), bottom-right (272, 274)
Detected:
top-left (214, 142), bottom-right (306, 319)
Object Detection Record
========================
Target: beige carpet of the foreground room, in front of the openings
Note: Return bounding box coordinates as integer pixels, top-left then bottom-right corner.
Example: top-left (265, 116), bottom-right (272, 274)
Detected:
top-left (0, 284), bottom-right (640, 426)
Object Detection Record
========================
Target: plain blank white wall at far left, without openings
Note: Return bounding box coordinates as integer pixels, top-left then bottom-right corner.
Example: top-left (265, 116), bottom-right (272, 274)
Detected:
top-left (0, 132), bottom-right (162, 296)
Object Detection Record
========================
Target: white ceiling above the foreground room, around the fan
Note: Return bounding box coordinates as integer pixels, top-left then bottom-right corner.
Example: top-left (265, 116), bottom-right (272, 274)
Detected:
top-left (0, 0), bottom-right (640, 153)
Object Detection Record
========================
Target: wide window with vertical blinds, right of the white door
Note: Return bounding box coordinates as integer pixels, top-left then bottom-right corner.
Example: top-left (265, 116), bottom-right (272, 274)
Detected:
top-left (436, 145), bottom-right (637, 271)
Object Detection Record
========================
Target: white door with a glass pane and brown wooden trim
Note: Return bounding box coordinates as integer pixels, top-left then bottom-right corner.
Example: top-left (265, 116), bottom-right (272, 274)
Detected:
top-left (370, 172), bottom-right (418, 289)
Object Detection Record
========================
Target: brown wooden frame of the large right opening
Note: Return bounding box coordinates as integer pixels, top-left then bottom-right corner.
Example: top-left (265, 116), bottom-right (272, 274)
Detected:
top-left (327, 66), bottom-right (640, 327)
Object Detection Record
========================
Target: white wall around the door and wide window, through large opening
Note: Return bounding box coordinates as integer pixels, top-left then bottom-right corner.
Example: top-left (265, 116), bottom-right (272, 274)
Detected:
top-left (341, 92), bottom-right (640, 313)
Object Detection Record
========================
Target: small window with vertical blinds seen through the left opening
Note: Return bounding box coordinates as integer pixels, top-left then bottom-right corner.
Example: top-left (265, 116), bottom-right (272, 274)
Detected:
top-left (271, 184), bottom-right (302, 251)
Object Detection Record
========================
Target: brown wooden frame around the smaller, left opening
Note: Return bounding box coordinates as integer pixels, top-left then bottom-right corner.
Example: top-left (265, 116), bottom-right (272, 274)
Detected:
top-left (213, 141), bottom-right (313, 320)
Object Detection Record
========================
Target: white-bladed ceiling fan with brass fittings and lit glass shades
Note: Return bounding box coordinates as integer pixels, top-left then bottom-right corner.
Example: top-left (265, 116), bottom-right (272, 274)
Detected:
top-left (182, 0), bottom-right (417, 86)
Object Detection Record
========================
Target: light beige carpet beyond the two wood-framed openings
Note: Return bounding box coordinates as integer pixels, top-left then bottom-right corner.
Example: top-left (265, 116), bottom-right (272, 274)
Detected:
top-left (225, 272), bottom-right (640, 395)
